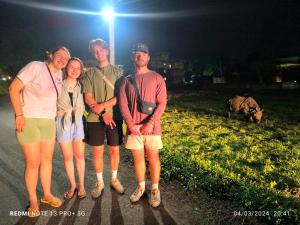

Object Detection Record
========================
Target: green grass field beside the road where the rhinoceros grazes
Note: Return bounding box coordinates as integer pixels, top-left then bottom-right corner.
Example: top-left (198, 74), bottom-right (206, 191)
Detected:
top-left (161, 90), bottom-right (300, 224)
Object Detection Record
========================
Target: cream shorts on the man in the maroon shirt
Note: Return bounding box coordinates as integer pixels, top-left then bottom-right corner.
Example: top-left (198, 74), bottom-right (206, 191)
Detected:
top-left (125, 135), bottom-right (163, 150)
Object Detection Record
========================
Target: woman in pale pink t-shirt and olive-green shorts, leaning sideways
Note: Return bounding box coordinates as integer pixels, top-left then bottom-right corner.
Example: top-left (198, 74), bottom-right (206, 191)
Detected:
top-left (9, 47), bottom-right (70, 217)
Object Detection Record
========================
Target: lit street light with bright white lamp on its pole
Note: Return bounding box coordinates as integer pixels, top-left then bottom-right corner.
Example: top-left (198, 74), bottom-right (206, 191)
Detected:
top-left (102, 9), bottom-right (115, 65)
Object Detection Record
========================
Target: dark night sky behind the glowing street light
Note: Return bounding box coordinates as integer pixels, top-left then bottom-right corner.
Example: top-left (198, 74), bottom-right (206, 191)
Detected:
top-left (0, 0), bottom-right (300, 68)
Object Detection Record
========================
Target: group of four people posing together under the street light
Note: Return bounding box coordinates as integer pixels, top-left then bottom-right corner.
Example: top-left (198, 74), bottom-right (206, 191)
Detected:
top-left (9, 39), bottom-right (167, 217)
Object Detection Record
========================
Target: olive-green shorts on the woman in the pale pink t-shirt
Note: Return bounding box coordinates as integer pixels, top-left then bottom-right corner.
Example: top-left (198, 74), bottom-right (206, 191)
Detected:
top-left (16, 118), bottom-right (56, 145)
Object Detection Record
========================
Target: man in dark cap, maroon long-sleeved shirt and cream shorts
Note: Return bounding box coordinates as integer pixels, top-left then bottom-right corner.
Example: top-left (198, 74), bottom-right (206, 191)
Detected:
top-left (119, 43), bottom-right (167, 207)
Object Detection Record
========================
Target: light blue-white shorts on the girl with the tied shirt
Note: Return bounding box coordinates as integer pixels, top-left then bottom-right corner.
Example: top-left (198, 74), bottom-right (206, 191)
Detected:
top-left (56, 117), bottom-right (84, 143)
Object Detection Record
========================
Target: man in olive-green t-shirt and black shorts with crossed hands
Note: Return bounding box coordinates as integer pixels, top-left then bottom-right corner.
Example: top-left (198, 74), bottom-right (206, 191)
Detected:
top-left (83, 39), bottom-right (124, 198)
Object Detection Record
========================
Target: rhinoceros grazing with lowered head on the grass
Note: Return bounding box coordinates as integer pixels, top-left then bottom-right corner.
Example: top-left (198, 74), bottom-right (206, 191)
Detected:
top-left (227, 95), bottom-right (263, 123)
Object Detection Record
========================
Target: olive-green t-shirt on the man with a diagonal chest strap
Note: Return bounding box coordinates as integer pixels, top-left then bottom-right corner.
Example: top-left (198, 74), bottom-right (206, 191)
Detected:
top-left (83, 65), bottom-right (123, 122)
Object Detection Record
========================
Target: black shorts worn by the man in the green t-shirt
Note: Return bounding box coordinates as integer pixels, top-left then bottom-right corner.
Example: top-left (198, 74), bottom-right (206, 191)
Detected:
top-left (85, 121), bottom-right (123, 146)
